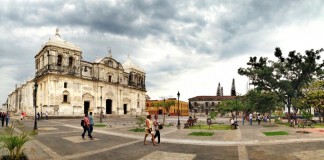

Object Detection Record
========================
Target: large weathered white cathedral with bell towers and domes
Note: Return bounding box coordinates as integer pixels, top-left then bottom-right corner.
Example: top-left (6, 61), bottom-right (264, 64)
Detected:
top-left (8, 29), bottom-right (146, 115)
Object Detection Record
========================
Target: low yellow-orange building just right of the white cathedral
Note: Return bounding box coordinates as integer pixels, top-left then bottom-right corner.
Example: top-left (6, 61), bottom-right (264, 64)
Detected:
top-left (146, 98), bottom-right (189, 116)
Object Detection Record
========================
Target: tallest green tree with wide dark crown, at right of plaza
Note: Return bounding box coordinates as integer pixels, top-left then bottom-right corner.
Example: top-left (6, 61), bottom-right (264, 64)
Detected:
top-left (238, 48), bottom-right (324, 122)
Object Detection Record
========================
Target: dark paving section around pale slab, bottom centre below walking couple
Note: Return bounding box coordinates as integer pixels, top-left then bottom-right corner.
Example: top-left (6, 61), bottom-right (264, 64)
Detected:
top-left (68, 142), bottom-right (239, 160)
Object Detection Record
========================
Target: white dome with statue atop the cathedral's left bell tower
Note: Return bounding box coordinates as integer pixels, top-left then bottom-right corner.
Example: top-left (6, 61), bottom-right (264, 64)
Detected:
top-left (45, 28), bottom-right (81, 52)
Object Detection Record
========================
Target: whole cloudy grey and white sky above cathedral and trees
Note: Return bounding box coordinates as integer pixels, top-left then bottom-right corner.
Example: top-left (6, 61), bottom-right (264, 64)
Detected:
top-left (0, 0), bottom-right (324, 103)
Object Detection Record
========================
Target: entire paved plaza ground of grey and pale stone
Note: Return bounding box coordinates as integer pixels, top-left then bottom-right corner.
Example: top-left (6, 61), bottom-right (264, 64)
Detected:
top-left (0, 117), bottom-right (324, 160)
